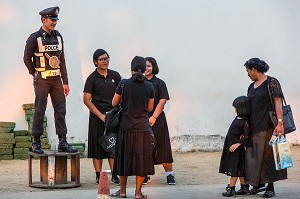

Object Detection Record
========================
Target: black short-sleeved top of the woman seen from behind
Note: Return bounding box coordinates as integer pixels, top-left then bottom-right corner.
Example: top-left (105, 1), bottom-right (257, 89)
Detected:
top-left (116, 77), bottom-right (154, 131)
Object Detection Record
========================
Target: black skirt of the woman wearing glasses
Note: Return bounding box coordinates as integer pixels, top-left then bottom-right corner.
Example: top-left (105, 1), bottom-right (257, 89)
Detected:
top-left (87, 112), bottom-right (110, 159)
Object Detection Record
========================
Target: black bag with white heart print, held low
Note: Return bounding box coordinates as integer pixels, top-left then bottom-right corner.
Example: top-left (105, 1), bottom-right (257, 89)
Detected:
top-left (98, 129), bottom-right (117, 158)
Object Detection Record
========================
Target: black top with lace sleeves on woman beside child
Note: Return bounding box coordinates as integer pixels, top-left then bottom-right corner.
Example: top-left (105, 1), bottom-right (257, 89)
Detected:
top-left (247, 76), bottom-right (282, 133)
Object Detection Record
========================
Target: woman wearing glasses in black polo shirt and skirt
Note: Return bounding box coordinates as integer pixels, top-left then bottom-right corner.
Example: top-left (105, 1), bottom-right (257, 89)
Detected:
top-left (83, 49), bottom-right (121, 184)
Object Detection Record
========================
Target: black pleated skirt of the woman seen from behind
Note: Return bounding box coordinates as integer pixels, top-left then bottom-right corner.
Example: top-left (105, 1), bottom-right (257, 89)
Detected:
top-left (114, 130), bottom-right (154, 176)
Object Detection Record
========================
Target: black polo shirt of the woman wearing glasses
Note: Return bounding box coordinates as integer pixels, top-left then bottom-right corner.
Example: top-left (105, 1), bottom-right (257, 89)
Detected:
top-left (83, 69), bottom-right (121, 114)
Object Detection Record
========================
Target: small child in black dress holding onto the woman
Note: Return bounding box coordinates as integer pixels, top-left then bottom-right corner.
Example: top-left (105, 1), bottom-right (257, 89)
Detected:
top-left (219, 96), bottom-right (250, 197)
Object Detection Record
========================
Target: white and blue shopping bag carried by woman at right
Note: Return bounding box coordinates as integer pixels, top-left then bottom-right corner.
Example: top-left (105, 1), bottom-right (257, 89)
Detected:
top-left (272, 136), bottom-right (293, 170)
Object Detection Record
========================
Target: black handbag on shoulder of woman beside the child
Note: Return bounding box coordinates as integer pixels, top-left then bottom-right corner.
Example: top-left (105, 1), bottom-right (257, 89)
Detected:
top-left (268, 77), bottom-right (296, 134)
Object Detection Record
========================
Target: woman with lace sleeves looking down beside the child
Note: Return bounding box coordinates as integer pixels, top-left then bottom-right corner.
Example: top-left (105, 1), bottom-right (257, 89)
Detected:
top-left (244, 58), bottom-right (287, 198)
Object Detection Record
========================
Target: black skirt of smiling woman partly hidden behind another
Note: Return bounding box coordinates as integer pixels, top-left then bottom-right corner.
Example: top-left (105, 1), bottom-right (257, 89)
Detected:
top-left (152, 112), bottom-right (173, 164)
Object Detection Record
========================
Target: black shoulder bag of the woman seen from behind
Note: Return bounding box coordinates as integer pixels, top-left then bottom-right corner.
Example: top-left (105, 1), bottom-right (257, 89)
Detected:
top-left (104, 84), bottom-right (124, 130)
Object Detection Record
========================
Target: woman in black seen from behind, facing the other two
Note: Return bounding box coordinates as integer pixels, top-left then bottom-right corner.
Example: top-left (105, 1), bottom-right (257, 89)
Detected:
top-left (112, 56), bottom-right (154, 198)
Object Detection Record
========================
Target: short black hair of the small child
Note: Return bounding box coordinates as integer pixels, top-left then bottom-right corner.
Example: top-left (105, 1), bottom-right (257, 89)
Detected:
top-left (232, 96), bottom-right (250, 117)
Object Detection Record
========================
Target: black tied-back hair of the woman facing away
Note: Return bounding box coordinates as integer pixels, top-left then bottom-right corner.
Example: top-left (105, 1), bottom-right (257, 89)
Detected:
top-left (131, 56), bottom-right (146, 82)
